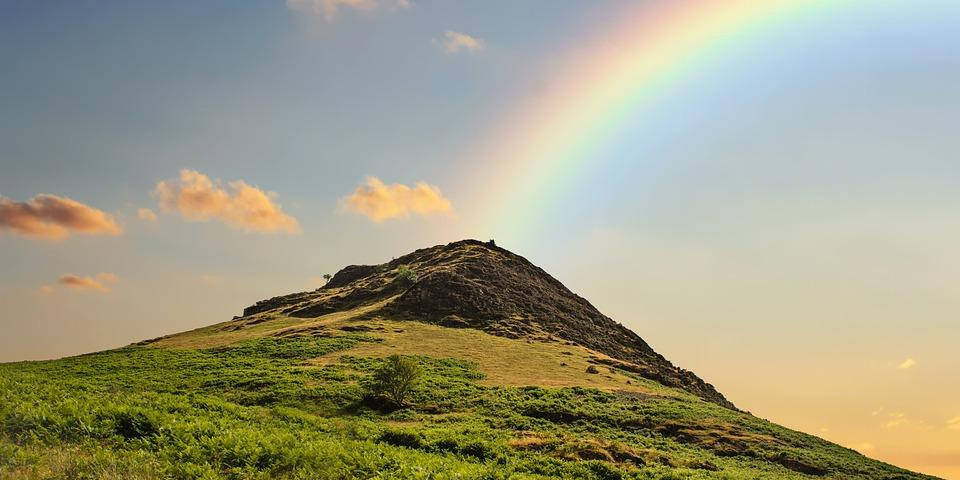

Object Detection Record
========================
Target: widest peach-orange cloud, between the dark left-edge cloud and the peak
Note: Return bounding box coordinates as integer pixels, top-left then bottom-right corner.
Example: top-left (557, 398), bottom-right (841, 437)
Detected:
top-left (153, 169), bottom-right (300, 233)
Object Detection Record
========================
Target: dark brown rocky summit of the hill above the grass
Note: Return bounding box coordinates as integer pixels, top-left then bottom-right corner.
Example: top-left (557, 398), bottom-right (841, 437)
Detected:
top-left (244, 240), bottom-right (735, 408)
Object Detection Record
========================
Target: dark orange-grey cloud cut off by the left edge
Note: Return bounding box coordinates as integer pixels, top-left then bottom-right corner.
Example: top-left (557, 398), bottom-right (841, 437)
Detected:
top-left (0, 193), bottom-right (123, 240)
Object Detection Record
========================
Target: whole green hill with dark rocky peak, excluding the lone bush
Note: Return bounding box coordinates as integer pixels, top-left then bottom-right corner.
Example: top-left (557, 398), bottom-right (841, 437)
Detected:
top-left (0, 240), bottom-right (932, 480)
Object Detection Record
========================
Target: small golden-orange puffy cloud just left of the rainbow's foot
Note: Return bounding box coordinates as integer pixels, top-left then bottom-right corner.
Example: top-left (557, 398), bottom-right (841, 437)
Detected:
top-left (340, 177), bottom-right (453, 223)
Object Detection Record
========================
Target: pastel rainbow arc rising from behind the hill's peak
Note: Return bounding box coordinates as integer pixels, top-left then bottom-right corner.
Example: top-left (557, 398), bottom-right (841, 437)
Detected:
top-left (478, 0), bottom-right (863, 236)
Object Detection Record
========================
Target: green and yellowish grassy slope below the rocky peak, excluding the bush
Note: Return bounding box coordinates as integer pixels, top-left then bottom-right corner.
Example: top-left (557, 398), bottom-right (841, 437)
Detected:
top-left (0, 312), bottom-right (929, 479)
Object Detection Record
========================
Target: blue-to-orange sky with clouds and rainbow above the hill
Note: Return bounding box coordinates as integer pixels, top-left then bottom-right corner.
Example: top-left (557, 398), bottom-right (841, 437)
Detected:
top-left (0, 0), bottom-right (960, 479)
